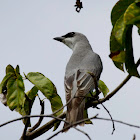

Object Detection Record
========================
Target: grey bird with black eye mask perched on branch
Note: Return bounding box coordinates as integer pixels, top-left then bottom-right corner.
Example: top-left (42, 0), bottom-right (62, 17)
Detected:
top-left (54, 32), bottom-right (103, 132)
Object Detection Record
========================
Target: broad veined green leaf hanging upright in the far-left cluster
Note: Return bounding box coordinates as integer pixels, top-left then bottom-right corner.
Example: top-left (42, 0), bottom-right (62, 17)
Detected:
top-left (7, 75), bottom-right (25, 110)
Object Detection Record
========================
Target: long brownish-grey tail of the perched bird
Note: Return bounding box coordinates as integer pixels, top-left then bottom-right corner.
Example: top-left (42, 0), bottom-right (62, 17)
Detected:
top-left (63, 99), bottom-right (85, 132)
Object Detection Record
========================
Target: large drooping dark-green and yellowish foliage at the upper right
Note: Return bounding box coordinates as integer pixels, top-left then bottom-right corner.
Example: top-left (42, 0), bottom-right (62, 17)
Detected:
top-left (110, 0), bottom-right (140, 77)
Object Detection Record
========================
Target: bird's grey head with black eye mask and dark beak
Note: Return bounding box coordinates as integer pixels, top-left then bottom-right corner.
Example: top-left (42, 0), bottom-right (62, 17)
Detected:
top-left (54, 32), bottom-right (88, 50)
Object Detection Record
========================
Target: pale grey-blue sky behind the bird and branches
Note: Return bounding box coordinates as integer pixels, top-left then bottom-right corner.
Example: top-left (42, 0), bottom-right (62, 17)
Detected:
top-left (0, 0), bottom-right (140, 140)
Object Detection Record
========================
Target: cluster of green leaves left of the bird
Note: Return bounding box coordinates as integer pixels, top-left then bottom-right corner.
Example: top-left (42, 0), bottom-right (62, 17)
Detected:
top-left (0, 65), bottom-right (63, 130)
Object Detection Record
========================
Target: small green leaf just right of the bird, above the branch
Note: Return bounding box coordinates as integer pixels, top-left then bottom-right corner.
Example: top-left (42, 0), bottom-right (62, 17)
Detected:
top-left (98, 80), bottom-right (109, 97)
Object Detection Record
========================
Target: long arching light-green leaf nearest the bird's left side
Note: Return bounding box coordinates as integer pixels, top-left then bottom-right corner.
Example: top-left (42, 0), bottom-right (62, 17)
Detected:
top-left (26, 72), bottom-right (63, 116)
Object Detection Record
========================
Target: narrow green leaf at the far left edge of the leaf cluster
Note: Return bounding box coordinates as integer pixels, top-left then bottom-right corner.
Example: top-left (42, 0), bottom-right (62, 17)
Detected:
top-left (0, 73), bottom-right (13, 93)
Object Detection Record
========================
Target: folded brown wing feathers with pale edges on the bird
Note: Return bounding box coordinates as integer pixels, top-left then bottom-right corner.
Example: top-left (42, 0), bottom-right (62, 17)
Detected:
top-left (65, 70), bottom-right (94, 111)
